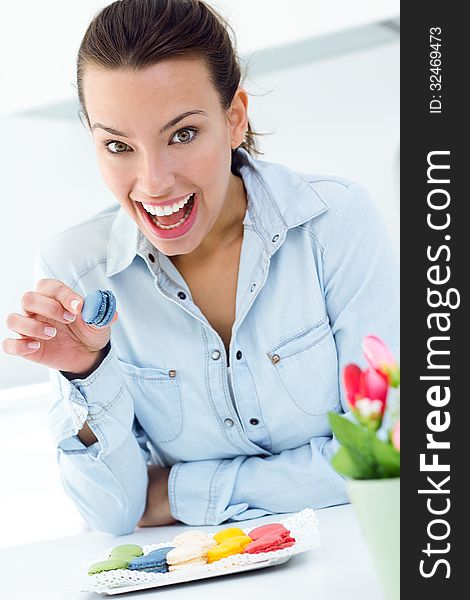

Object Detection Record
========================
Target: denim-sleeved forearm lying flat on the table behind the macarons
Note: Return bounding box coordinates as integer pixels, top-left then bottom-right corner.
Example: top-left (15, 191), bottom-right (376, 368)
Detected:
top-left (168, 437), bottom-right (348, 526)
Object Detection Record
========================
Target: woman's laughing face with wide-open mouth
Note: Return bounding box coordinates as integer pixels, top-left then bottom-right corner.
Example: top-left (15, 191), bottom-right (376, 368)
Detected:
top-left (83, 58), bottom-right (247, 256)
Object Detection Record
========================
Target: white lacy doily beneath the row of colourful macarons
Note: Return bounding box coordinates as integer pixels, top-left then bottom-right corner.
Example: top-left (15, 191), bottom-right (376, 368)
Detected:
top-left (81, 508), bottom-right (320, 594)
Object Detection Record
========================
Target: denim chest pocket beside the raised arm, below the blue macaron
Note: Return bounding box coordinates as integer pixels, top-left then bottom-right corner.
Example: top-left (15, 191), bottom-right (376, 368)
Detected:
top-left (119, 360), bottom-right (183, 443)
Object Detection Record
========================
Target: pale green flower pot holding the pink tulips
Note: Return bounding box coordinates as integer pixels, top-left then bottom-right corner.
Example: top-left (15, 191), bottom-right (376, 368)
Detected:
top-left (347, 477), bottom-right (400, 600)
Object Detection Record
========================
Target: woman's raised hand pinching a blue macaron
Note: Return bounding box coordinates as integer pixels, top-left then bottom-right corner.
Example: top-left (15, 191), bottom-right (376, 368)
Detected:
top-left (3, 279), bottom-right (118, 377)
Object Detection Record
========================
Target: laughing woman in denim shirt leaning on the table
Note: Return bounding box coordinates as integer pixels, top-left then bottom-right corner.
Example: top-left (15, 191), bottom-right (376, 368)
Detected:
top-left (4, 0), bottom-right (398, 534)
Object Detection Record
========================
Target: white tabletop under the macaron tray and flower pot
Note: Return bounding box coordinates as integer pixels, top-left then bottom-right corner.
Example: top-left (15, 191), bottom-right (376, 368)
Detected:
top-left (0, 505), bottom-right (383, 600)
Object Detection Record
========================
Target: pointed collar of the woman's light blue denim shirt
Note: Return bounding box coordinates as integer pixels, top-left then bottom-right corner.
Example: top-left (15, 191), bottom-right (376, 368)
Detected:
top-left (106, 148), bottom-right (327, 277)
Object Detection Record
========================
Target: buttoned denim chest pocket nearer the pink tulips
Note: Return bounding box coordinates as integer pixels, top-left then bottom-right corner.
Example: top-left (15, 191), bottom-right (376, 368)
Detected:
top-left (268, 317), bottom-right (340, 416)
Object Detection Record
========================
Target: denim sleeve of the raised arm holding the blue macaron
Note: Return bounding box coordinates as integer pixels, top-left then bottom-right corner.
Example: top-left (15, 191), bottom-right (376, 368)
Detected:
top-left (45, 347), bottom-right (150, 535)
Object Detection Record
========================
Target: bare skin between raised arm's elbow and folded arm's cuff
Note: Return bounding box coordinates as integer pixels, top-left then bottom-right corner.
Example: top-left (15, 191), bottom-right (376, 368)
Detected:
top-left (137, 465), bottom-right (176, 527)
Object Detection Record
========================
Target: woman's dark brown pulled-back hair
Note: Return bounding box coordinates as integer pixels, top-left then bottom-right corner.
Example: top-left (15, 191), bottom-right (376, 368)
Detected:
top-left (77, 0), bottom-right (259, 154)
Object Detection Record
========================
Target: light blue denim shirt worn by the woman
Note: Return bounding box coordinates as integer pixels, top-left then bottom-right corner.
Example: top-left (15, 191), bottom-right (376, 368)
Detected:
top-left (36, 149), bottom-right (399, 534)
